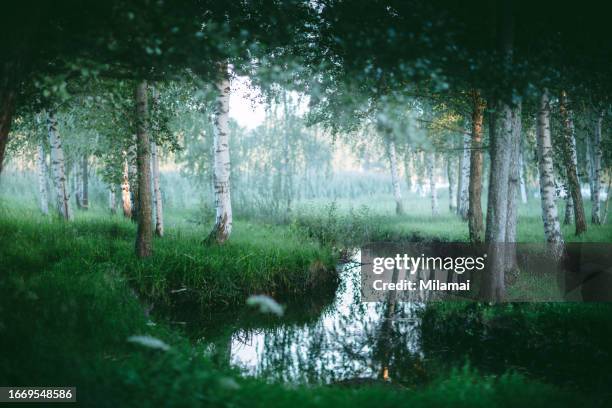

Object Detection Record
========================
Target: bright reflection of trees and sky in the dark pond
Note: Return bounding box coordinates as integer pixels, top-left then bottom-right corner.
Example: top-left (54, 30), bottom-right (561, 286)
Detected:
top-left (228, 253), bottom-right (423, 384)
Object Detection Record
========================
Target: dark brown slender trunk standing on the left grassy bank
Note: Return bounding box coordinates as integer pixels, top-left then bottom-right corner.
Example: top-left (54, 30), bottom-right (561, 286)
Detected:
top-left (135, 81), bottom-right (153, 258)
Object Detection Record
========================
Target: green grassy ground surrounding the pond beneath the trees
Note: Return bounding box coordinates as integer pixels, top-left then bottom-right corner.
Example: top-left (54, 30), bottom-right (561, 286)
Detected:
top-left (0, 199), bottom-right (612, 407)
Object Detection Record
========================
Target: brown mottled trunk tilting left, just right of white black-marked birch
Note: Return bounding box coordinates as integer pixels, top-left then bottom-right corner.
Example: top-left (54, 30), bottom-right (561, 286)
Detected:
top-left (559, 91), bottom-right (587, 235)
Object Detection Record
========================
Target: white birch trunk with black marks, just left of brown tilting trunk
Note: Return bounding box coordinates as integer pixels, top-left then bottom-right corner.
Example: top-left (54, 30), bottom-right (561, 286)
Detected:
top-left (536, 91), bottom-right (563, 249)
